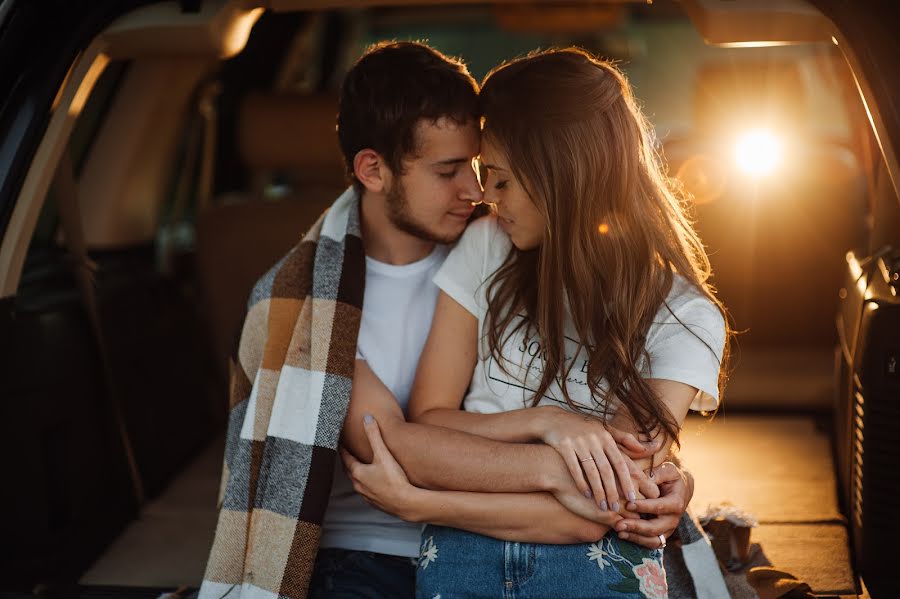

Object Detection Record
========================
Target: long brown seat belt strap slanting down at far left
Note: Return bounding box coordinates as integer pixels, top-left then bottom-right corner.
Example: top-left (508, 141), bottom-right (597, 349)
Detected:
top-left (53, 149), bottom-right (144, 508)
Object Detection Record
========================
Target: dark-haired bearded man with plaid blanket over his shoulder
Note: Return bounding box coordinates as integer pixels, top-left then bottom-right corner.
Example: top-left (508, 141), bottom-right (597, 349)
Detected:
top-left (201, 42), bottom-right (691, 598)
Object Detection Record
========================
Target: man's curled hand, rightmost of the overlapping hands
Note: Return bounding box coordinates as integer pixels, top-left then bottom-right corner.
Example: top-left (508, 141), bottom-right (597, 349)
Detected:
top-left (615, 462), bottom-right (694, 549)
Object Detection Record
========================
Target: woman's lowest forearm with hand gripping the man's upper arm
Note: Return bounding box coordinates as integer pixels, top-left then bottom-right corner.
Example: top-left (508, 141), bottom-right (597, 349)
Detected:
top-left (341, 419), bottom-right (624, 544)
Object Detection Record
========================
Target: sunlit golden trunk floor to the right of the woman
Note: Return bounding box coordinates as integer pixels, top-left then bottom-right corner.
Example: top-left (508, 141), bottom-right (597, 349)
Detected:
top-left (681, 414), bottom-right (855, 595)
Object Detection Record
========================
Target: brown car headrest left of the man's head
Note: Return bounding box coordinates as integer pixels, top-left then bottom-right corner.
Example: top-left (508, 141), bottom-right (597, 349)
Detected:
top-left (237, 92), bottom-right (346, 183)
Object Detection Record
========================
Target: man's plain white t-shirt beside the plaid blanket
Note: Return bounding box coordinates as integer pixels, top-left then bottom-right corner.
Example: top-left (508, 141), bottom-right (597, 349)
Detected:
top-left (321, 245), bottom-right (449, 557)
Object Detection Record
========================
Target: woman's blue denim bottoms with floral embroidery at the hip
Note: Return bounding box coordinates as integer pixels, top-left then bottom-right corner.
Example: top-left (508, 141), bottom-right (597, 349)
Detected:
top-left (416, 525), bottom-right (668, 599)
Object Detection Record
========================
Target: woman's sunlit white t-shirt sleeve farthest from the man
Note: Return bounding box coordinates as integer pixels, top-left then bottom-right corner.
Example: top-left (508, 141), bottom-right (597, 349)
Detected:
top-left (644, 294), bottom-right (725, 411)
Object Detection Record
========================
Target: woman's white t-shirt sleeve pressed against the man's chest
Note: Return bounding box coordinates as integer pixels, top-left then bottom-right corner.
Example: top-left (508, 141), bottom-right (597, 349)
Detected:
top-left (434, 216), bottom-right (496, 318)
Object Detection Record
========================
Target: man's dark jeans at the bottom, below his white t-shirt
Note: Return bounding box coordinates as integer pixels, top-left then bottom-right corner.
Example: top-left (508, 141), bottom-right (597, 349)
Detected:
top-left (308, 549), bottom-right (416, 599)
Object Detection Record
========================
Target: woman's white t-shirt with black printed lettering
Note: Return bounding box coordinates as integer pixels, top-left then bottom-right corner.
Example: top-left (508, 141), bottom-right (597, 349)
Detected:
top-left (434, 216), bottom-right (725, 422)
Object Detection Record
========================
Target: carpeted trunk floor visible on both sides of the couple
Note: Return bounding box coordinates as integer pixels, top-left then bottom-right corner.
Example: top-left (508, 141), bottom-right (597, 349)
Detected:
top-left (81, 414), bottom-right (854, 595)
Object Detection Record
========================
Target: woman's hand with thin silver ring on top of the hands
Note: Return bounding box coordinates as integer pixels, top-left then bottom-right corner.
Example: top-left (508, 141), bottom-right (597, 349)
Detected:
top-left (538, 406), bottom-right (659, 512)
